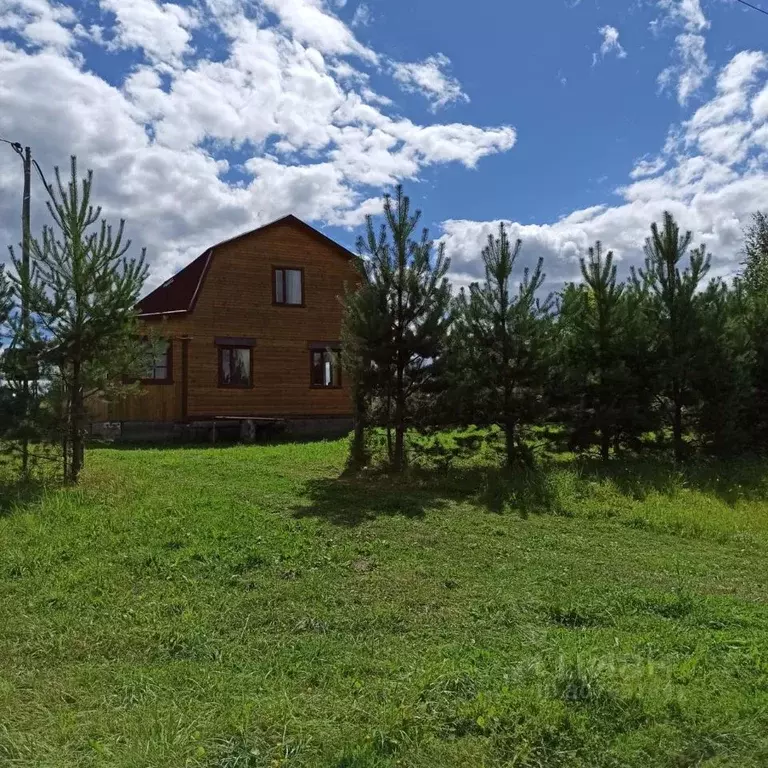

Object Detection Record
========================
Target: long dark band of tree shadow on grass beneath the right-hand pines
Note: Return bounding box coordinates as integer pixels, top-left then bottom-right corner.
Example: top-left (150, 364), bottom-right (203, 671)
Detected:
top-left (293, 456), bottom-right (768, 525)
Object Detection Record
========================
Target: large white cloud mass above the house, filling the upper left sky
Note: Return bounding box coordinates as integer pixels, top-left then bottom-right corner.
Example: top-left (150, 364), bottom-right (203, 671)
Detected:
top-left (0, 0), bottom-right (516, 284)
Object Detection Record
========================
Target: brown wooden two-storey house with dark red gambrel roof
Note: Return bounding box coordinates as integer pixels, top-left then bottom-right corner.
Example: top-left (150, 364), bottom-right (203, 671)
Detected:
top-left (92, 216), bottom-right (359, 436)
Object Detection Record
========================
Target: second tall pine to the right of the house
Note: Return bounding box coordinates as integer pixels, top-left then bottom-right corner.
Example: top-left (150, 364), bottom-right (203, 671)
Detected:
top-left (452, 224), bottom-right (552, 466)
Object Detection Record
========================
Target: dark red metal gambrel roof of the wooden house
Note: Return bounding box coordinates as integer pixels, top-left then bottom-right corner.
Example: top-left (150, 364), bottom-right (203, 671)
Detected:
top-left (136, 214), bottom-right (355, 317)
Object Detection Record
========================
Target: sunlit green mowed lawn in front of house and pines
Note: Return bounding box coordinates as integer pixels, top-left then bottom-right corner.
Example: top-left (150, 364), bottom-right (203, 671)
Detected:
top-left (0, 441), bottom-right (768, 768)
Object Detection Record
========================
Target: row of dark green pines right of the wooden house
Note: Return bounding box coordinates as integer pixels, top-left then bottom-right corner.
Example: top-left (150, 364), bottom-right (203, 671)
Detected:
top-left (343, 188), bottom-right (768, 471)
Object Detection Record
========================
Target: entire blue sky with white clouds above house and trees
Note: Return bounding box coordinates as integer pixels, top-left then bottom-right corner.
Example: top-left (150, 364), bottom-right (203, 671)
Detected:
top-left (0, 0), bottom-right (768, 286)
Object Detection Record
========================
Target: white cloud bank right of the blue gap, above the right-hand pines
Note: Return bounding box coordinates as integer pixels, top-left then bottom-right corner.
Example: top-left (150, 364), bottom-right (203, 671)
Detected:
top-left (442, 51), bottom-right (768, 288)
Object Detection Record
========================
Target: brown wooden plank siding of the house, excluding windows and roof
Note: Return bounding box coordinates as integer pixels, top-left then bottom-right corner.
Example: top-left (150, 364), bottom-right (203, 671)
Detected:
top-left (92, 218), bottom-right (358, 422)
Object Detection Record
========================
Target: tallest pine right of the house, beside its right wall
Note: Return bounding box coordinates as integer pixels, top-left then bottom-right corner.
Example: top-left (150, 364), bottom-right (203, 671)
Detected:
top-left (346, 186), bottom-right (451, 472)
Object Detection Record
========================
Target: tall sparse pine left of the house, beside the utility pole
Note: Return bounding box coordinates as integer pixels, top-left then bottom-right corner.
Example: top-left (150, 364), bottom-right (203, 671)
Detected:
top-left (32, 157), bottom-right (147, 482)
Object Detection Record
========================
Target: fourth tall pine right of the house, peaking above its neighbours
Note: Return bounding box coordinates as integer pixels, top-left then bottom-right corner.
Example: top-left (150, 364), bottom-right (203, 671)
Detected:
top-left (639, 212), bottom-right (710, 461)
